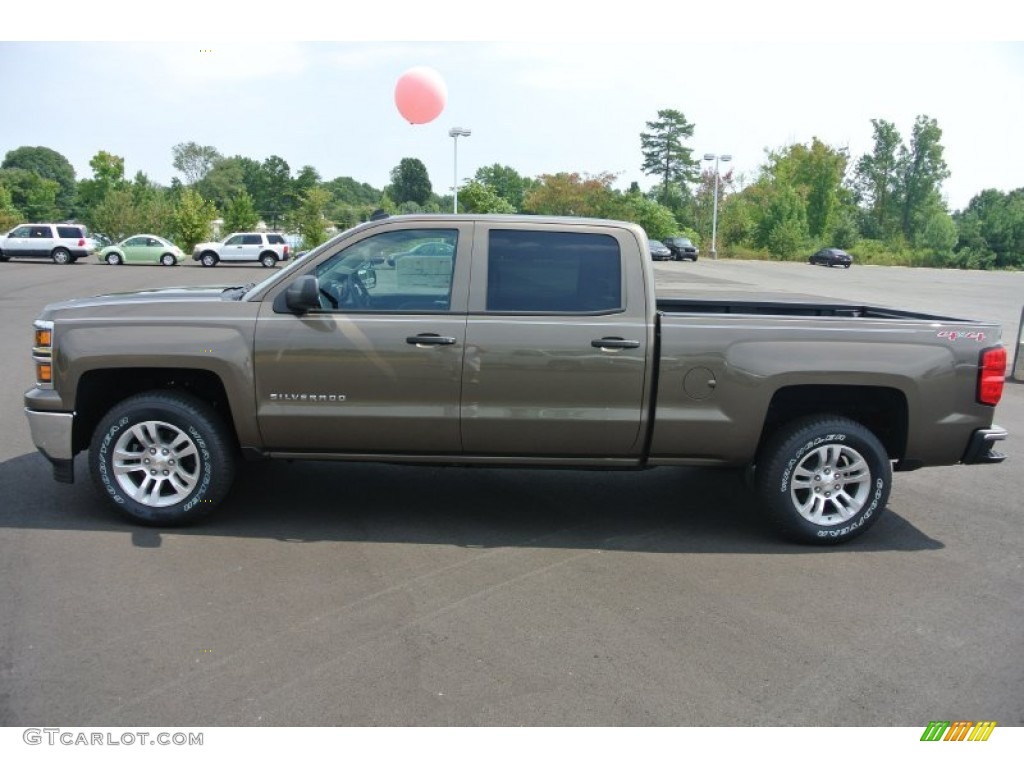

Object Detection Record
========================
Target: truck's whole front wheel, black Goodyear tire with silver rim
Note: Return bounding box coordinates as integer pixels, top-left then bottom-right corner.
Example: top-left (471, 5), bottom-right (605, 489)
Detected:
top-left (89, 390), bottom-right (234, 525)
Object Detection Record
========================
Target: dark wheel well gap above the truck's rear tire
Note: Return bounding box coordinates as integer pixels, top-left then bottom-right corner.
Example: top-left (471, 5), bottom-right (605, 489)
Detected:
top-left (758, 384), bottom-right (908, 460)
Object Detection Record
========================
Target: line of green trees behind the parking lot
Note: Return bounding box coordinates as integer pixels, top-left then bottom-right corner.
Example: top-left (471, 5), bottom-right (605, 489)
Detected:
top-left (0, 115), bottom-right (1024, 268)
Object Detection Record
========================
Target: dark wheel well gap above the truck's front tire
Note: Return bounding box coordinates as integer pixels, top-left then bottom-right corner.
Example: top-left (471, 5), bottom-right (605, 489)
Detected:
top-left (72, 368), bottom-right (237, 453)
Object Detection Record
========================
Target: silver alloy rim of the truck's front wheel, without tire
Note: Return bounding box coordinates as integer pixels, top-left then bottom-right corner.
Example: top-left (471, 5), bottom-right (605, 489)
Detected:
top-left (113, 421), bottom-right (200, 507)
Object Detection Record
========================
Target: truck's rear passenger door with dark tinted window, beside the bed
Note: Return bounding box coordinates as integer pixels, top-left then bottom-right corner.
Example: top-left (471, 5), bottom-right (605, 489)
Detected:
top-left (462, 222), bottom-right (653, 458)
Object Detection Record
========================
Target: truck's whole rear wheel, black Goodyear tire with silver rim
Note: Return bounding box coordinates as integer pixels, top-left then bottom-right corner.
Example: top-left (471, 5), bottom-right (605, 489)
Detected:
top-left (757, 416), bottom-right (892, 545)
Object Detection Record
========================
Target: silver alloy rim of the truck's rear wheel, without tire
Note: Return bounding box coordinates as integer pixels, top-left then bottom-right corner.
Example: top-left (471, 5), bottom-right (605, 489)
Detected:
top-left (790, 443), bottom-right (871, 525)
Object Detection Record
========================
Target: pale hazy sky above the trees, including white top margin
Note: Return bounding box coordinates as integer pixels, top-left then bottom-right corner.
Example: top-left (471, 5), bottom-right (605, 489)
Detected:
top-left (0, 0), bottom-right (1024, 210)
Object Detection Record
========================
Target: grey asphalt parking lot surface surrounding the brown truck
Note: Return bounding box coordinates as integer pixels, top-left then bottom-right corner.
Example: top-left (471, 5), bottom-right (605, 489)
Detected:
top-left (0, 260), bottom-right (1024, 728)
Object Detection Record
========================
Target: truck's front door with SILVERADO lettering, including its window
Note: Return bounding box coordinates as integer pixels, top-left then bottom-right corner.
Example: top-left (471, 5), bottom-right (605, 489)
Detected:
top-left (255, 223), bottom-right (471, 456)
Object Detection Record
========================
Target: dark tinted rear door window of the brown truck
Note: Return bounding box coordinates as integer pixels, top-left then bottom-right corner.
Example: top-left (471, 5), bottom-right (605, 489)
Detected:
top-left (487, 229), bottom-right (623, 312)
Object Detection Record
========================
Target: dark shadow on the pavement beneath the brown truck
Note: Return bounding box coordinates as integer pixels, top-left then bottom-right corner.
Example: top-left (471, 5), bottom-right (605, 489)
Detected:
top-left (0, 454), bottom-right (944, 554)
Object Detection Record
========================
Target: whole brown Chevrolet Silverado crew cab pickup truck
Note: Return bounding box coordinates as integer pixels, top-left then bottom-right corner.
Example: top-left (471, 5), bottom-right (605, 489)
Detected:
top-left (25, 215), bottom-right (1007, 544)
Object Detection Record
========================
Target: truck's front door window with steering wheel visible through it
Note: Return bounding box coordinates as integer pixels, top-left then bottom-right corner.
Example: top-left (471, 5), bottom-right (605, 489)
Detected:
top-left (315, 229), bottom-right (459, 312)
